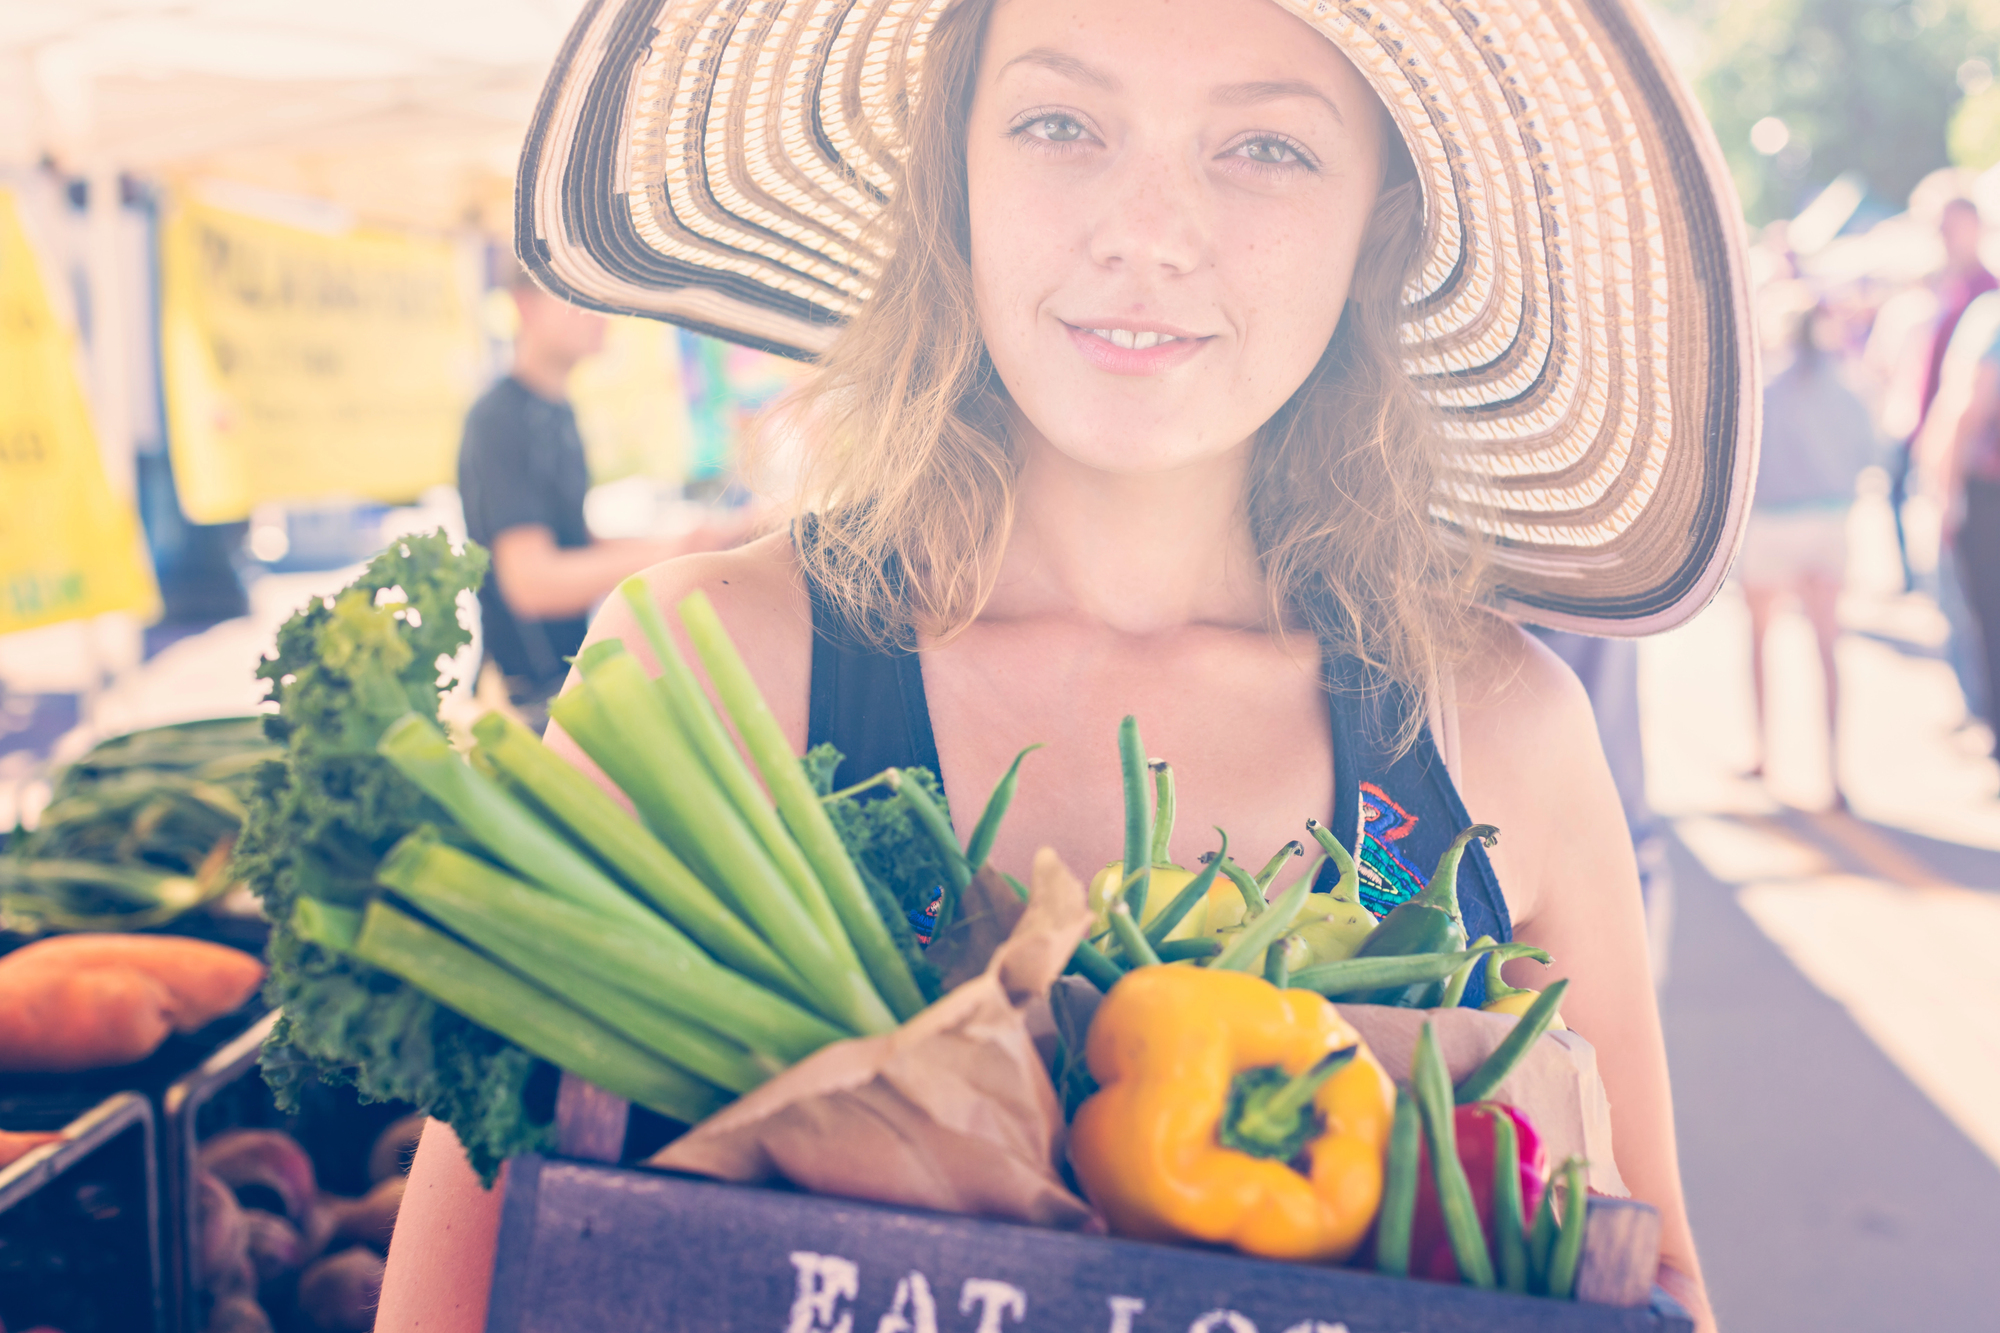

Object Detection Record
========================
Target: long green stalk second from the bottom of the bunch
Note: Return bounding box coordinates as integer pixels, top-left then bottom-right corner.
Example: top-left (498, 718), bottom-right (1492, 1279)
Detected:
top-left (376, 833), bottom-right (848, 1056)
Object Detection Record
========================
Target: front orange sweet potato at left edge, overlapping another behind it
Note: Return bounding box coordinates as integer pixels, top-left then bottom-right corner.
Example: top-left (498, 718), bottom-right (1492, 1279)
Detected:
top-left (0, 960), bottom-right (174, 1073)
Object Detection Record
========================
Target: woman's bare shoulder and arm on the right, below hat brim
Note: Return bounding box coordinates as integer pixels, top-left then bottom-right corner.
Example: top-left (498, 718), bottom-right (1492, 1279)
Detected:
top-left (1458, 624), bottom-right (1714, 1331)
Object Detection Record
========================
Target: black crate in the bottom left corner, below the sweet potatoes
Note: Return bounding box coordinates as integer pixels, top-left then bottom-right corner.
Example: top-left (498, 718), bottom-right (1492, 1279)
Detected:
top-left (0, 1093), bottom-right (166, 1333)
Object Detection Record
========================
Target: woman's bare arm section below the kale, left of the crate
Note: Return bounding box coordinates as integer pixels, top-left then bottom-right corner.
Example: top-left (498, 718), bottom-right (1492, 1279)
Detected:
top-left (374, 1121), bottom-right (506, 1333)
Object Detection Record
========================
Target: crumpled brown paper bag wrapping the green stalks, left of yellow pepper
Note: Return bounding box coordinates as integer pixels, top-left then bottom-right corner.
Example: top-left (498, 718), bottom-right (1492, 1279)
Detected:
top-left (648, 849), bottom-right (1094, 1229)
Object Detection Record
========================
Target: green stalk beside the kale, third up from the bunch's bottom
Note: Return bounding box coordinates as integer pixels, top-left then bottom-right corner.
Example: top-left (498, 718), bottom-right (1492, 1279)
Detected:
top-left (376, 713), bottom-right (658, 921)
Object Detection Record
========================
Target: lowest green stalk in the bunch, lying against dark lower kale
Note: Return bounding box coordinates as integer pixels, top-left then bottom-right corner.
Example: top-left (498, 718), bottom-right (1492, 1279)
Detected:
top-left (354, 901), bottom-right (728, 1125)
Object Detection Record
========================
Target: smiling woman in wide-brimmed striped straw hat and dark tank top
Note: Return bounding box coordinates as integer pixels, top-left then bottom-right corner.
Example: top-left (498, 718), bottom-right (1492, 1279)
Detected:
top-left (378, 0), bottom-right (1750, 1329)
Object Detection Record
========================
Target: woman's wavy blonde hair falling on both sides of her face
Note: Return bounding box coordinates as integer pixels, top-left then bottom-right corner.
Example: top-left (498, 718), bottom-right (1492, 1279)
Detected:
top-left (786, 0), bottom-right (1482, 728)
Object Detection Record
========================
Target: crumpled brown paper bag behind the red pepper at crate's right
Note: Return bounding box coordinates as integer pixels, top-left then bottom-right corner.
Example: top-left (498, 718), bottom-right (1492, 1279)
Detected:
top-left (1338, 1005), bottom-right (1632, 1199)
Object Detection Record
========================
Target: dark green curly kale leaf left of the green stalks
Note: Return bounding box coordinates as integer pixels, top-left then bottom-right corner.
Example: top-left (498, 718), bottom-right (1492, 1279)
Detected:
top-left (234, 532), bottom-right (554, 1181)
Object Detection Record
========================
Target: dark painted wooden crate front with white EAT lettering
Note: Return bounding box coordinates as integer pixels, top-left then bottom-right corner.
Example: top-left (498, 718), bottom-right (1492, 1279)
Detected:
top-left (486, 1157), bottom-right (1692, 1333)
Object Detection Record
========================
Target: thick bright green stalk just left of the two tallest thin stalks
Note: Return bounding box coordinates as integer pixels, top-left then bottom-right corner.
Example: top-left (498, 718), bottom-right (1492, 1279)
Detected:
top-left (550, 644), bottom-right (896, 1033)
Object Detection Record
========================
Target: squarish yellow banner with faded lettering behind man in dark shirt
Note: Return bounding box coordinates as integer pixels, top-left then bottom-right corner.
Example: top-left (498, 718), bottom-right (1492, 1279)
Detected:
top-left (160, 200), bottom-right (480, 522)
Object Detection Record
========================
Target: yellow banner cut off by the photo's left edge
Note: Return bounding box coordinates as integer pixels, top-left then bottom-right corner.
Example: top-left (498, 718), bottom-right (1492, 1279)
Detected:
top-left (0, 190), bottom-right (158, 634)
